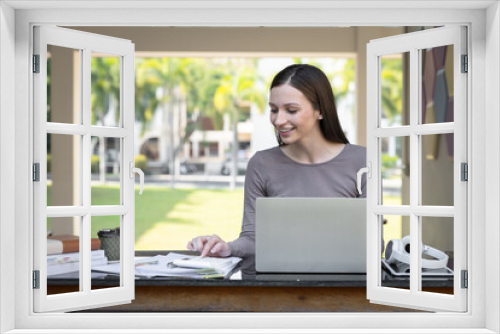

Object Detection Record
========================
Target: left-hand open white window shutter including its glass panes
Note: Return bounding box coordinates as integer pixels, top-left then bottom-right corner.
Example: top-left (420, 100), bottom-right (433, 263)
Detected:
top-left (33, 26), bottom-right (135, 312)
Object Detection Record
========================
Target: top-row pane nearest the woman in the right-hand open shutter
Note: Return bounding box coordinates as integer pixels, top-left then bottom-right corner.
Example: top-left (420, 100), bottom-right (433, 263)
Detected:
top-left (380, 52), bottom-right (410, 127)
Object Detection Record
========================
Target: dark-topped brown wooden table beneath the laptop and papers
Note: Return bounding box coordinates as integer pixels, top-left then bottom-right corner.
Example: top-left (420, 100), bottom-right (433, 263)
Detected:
top-left (48, 252), bottom-right (453, 312)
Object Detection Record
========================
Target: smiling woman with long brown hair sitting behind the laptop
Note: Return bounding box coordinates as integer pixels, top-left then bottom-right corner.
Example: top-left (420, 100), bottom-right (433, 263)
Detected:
top-left (187, 65), bottom-right (366, 274)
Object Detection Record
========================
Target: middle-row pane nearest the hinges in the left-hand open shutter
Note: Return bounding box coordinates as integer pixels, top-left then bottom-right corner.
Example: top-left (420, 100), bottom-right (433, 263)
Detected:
top-left (47, 133), bottom-right (82, 206)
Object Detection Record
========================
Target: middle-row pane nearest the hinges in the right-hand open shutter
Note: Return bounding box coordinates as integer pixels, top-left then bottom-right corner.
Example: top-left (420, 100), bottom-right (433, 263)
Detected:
top-left (421, 133), bottom-right (454, 206)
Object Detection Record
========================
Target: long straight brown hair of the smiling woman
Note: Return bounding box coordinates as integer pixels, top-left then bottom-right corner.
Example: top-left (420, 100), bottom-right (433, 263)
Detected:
top-left (270, 64), bottom-right (349, 145)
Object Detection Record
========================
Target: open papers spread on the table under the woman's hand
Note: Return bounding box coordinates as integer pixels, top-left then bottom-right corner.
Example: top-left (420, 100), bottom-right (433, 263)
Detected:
top-left (92, 253), bottom-right (241, 279)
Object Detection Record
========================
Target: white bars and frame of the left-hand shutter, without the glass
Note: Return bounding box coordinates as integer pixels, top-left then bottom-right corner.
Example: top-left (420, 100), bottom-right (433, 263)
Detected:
top-left (33, 25), bottom-right (135, 312)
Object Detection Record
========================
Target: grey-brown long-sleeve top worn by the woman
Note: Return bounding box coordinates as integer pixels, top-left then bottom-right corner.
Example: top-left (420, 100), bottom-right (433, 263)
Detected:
top-left (229, 144), bottom-right (366, 270)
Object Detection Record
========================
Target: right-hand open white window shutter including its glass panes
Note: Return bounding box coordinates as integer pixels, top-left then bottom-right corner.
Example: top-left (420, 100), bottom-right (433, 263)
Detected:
top-left (367, 26), bottom-right (470, 312)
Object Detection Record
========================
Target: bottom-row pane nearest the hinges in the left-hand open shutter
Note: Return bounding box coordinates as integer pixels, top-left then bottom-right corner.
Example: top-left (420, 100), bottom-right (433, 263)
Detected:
top-left (47, 217), bottom-right (82, 295)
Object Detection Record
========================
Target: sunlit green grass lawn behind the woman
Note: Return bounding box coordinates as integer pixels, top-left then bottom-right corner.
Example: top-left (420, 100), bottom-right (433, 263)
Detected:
top-left (47, 185), bottom-right (401, 250)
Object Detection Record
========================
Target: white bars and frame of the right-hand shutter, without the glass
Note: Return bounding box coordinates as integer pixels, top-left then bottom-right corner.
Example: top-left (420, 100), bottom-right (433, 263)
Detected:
top-left (367, 25), bottom-right (468, 312)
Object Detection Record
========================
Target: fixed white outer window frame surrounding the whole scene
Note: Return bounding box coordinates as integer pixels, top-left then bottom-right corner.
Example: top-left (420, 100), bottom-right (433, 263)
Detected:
top-left (0, 1), bottom-right (500, 333)
